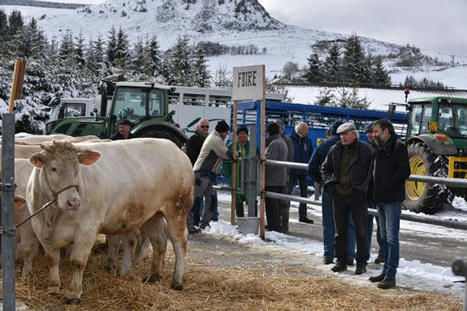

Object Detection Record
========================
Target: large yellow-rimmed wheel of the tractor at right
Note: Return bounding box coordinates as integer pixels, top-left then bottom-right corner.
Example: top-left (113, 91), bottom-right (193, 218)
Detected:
top-left (404, 142), bottom-right (454, 214)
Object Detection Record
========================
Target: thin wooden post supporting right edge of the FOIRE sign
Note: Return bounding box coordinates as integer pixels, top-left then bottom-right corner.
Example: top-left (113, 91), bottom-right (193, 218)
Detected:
top-left (259, 66), bottom-right (266, 240)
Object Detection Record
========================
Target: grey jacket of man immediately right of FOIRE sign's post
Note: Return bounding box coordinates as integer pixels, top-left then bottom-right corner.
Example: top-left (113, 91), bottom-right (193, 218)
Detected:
top-left (266, 134), bottom-right (289, 187)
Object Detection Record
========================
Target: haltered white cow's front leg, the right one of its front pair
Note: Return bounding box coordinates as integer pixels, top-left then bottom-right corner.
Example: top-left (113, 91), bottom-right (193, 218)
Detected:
top-left (66, 236), bottom-right (97, 304)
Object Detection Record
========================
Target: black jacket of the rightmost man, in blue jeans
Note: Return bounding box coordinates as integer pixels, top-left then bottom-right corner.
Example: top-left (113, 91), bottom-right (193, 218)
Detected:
top-left (372, 136), bottom-right (410, 203)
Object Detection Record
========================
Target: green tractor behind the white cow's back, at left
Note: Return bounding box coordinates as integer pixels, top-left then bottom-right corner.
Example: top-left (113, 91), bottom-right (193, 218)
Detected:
top-left (46, 82), bottom-right (188, 147)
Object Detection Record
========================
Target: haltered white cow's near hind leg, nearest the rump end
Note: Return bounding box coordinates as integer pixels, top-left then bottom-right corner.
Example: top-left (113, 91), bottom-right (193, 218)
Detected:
top-left (166, 213), bottom-right (186, 290)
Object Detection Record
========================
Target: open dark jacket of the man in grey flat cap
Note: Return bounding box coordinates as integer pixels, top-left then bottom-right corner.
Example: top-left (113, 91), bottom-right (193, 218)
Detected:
top-left (321, 140), bottom-right (373, 195)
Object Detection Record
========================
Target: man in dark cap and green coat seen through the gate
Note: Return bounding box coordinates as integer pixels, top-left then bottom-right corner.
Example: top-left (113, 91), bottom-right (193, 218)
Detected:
top-left (222, 126), bottom-right (252, 217)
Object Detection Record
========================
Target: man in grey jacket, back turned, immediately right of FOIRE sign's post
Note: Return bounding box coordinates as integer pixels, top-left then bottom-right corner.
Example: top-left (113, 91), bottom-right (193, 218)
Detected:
top-left (266, 123), bottom-right (288, 232)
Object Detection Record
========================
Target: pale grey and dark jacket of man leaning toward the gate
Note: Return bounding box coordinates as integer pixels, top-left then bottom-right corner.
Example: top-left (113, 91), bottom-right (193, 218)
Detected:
top-left (193, 131), bottom-right (232, 178)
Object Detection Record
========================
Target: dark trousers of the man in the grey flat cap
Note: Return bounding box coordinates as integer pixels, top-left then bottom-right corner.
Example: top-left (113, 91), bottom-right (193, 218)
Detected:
top-left (333, 191), bottom-right (369, 263)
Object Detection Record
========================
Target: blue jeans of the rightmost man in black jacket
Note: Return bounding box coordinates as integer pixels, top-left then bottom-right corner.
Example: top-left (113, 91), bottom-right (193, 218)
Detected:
top-left (376, 202), bottom-right (402, 279)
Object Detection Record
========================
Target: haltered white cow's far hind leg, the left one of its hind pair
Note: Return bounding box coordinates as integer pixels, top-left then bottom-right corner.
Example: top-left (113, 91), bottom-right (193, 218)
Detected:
top-left (141, 214), bottom-right (167, 282)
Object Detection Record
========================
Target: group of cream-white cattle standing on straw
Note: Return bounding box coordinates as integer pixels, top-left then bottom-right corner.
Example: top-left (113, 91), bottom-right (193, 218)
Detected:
top-left (0, 134), bottom-right (193, 304)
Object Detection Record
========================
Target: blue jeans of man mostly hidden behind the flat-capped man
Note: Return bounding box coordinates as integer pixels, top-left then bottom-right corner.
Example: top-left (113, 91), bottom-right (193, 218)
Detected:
top-left (321, 191), bottom-right (355, 263)
